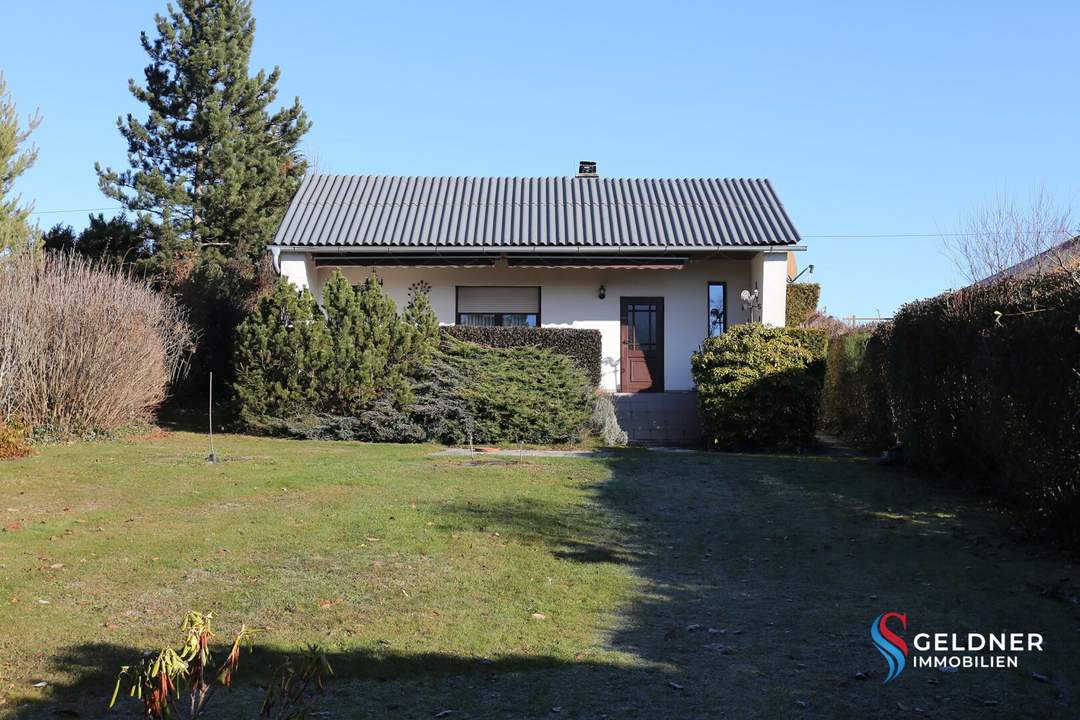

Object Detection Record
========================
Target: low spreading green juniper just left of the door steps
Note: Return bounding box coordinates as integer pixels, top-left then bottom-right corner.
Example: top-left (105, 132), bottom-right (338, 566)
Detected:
top-left (442, 337), bottom-right (592, 444)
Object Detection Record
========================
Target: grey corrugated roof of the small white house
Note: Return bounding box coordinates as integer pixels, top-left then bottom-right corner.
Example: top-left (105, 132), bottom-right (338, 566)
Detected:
top-left (273, 175), bottom-right (799, 250)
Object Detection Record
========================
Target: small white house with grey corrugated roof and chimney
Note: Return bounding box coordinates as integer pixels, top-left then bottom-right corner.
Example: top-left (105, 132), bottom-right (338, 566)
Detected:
top-left (270, 163), bottom-right (802, 393)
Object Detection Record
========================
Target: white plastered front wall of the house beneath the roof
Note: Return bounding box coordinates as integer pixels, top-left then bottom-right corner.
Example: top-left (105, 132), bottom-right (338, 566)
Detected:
top-left (278, 249), bottom-right (787, 391)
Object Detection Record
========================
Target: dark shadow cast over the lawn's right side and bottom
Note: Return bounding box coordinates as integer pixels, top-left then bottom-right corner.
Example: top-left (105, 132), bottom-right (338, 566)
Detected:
top-left (10, 450), bottom-right (1078, 718)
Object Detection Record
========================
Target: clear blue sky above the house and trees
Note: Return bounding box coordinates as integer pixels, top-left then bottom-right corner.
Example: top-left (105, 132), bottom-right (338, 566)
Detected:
top-left (0, 0), bottom-right (1080, 315)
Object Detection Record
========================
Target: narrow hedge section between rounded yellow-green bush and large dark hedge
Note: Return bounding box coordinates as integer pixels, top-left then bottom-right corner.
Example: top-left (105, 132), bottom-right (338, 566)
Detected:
top-left (822, 327), bottom-right (895, 450)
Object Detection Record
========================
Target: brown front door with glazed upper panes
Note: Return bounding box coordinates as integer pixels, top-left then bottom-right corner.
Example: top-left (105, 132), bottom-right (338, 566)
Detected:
top-left (619, 298), bottom-right (664, 393)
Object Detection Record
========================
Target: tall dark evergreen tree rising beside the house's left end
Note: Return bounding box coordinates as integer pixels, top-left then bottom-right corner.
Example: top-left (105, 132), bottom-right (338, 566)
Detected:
top-left (95, 0), bottom-right (310, 394)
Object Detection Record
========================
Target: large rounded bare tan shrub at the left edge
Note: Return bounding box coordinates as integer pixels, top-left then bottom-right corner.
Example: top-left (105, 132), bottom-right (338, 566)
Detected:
top-left (0, 254), bottom-right (192, 435)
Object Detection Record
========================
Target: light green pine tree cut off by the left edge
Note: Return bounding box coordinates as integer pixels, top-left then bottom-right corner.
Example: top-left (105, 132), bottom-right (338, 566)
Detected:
top-left (0, 73), bottom-right (41, 257)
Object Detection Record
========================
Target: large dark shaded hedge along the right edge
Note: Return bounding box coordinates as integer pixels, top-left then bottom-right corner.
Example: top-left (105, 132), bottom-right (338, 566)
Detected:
top-left (882, 272), bottom-right (1080, 541)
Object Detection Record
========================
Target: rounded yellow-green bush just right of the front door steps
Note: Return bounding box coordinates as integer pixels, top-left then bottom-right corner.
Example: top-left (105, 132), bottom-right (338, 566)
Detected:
top-left (691, 324), bottom-right (825, 449)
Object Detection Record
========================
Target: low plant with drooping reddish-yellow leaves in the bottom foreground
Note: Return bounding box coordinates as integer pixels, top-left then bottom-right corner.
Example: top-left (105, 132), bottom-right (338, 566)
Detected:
top-left (109, 611), bottom-right (333, 720)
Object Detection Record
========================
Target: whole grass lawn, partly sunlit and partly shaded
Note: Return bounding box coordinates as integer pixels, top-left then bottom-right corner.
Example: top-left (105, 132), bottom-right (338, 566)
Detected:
top-left (0, 433), bottom-right (1080, 720)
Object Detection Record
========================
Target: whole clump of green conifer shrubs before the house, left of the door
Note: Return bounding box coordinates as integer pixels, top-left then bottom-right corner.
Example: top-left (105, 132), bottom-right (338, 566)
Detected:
top-left (234, 273), bottom-right (592, 444)
